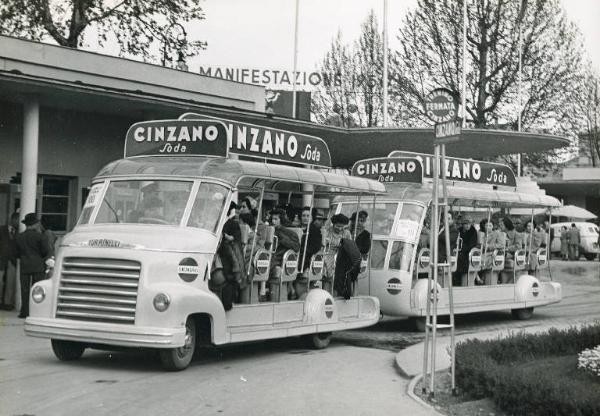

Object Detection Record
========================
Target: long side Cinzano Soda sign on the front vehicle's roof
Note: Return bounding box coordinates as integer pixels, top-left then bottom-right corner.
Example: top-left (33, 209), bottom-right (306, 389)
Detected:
top-left (180, 113), bottom-right (331, 167)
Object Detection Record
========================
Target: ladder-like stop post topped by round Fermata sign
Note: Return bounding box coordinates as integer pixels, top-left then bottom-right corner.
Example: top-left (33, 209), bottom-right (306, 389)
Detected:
top-left (423, 88), bottom-right (462, 397)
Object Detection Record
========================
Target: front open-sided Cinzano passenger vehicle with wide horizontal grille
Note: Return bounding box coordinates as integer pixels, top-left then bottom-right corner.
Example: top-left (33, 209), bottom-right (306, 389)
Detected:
top-left (25, 114), bottom-right (385, 370)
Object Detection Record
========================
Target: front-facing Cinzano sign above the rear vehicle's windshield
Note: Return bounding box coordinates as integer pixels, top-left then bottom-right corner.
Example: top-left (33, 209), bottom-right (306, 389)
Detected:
top-left (352, 157), bottom-right (423, 183)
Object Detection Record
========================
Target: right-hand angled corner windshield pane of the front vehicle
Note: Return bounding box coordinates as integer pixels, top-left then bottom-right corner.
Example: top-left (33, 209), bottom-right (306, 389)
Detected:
top-left (188, 182), bottom-right (228, 233)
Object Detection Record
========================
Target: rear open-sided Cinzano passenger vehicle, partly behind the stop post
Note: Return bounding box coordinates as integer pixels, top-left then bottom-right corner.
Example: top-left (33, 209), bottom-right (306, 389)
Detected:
top-left (333, 152), bottom-right (562, 331)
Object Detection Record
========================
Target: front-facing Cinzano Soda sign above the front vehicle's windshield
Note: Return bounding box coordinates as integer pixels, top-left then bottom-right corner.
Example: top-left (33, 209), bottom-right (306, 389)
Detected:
top-left (125, 120), bottom-right (227, 157)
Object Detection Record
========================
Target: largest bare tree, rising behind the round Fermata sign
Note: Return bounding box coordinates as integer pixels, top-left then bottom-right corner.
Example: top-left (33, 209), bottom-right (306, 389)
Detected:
top-left (390, 0), bottom-right (583, 169)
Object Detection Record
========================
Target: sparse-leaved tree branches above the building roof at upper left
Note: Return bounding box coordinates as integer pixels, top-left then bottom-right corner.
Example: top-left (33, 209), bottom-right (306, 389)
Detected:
top-left (0, 0), bottom-right (206, 61)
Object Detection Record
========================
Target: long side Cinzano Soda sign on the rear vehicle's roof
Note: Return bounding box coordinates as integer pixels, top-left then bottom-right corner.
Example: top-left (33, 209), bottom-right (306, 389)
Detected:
top-left (389, 150), bottom-right (517, 186)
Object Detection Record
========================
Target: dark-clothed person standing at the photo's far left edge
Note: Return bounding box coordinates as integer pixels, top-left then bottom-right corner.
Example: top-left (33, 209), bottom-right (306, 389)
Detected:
top-left (0, 212), bottom-right (19, 311)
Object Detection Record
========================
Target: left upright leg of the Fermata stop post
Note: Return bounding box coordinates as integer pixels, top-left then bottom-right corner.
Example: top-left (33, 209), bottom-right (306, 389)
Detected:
top-left (427, 144), bottom-right (445, 397)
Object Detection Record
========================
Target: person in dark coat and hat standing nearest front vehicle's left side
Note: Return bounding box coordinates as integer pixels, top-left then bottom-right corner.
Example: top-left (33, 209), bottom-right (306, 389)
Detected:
top-left (16, 212), bottom-right (51, 318)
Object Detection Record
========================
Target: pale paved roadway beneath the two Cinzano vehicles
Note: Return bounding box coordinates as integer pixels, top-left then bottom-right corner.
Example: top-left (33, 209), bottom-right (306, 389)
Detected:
top-left (0, 261), bottom-right (600, 416)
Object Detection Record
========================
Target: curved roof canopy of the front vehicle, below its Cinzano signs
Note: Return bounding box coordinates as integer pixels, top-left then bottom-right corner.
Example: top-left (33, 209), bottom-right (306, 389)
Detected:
top-left (96, 156), bottom-right (385, 193)
